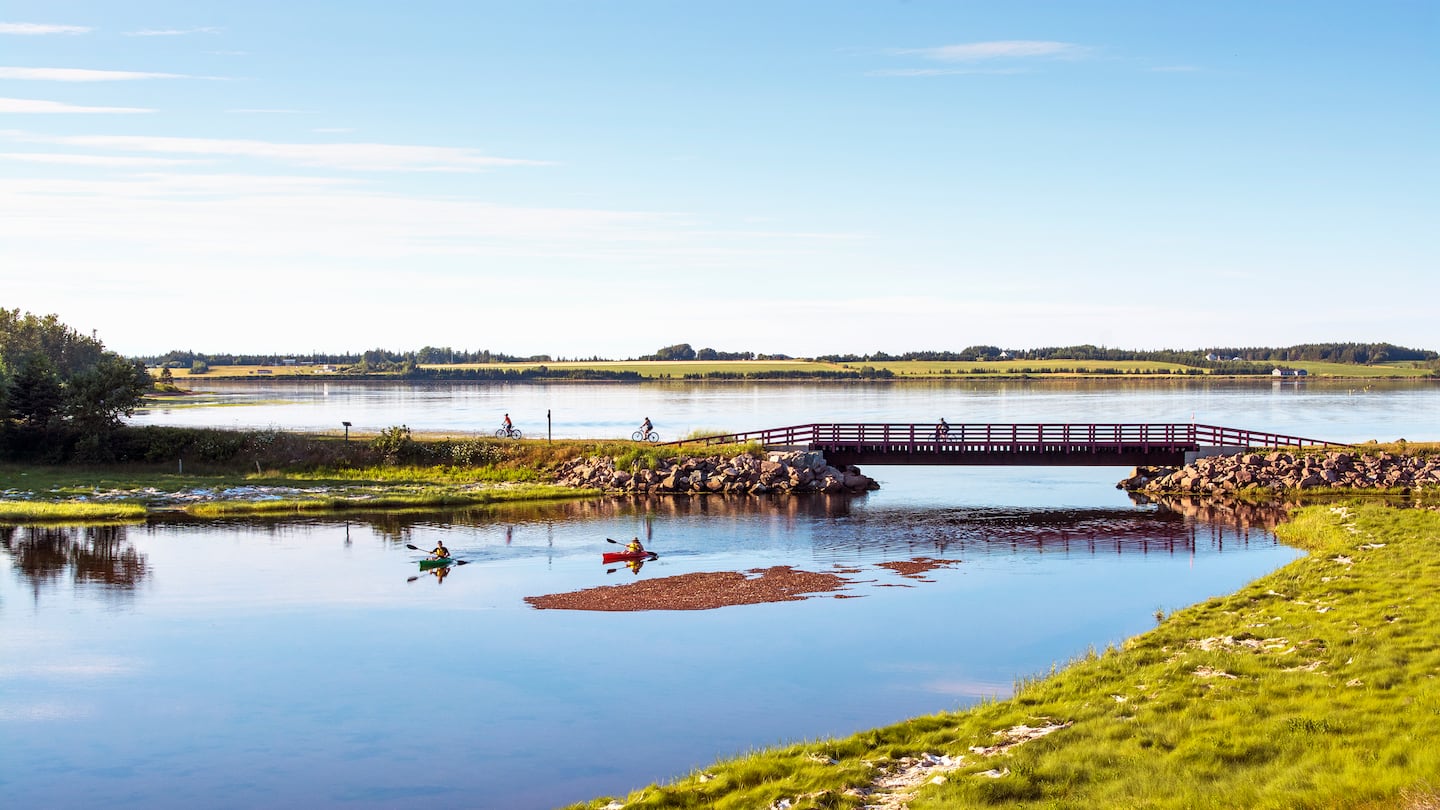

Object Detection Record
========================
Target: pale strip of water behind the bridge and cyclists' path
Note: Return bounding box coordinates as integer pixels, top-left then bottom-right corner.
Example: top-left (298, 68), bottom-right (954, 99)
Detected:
top-left (132, 379), bottom-right (1440, 442)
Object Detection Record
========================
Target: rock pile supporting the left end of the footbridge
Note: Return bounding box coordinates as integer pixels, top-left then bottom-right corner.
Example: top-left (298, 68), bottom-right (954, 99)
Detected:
top-left (556, 451), bottom-right (880, 494)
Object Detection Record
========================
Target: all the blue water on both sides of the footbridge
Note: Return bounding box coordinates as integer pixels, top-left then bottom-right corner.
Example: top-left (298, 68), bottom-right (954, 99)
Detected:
top-left (0, 383), bottom-right (1440, 809)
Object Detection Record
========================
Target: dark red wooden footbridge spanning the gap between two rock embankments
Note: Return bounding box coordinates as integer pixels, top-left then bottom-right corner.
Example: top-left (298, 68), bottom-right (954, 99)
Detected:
top-left (671, 424), bottom-right (1338, 467)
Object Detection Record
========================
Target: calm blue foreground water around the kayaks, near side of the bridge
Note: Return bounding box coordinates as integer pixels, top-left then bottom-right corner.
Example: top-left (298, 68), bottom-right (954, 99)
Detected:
top-left (0, 484), bottom-right (1296, 810)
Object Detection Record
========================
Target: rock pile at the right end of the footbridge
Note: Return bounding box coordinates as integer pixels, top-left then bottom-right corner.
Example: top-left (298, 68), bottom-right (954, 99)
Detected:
top-left (1116, 451), bottom-right (1440, 494)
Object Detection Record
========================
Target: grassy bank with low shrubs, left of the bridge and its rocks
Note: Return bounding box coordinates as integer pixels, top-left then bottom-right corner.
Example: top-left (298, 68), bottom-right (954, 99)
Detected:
top-left (0, 428), bottom-right (760, 523)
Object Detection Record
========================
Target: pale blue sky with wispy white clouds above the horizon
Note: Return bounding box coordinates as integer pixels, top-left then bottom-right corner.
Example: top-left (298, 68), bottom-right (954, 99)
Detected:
top-left (0, 0), bottom-right (1440, 357)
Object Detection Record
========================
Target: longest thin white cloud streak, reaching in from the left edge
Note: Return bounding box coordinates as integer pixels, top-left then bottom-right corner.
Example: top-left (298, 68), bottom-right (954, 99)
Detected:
top-left (6, 131), bottom-right (550, 172)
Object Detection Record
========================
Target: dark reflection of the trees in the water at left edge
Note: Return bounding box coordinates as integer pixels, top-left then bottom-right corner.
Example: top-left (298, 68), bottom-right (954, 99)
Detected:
top-left (0, 526), bottom-right (150, 598)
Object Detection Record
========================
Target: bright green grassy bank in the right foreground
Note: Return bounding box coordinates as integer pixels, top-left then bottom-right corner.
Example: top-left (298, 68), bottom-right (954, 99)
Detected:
top-left (576, 504), bottom-right (1440, 810)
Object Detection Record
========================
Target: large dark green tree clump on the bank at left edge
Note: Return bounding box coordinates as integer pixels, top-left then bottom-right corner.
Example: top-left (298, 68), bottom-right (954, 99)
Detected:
top-left (0, 307), bottom-right (153, 461)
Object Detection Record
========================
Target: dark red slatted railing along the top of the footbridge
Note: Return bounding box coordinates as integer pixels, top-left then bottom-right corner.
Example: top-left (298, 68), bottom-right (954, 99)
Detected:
top-left (670, 422), bottom-right (1344, 453)
